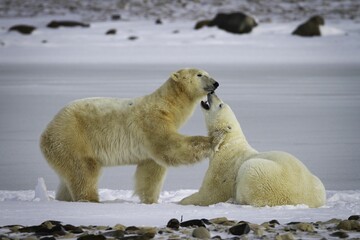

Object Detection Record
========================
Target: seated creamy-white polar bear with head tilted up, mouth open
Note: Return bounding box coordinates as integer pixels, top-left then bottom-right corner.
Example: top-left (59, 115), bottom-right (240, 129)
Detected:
top-left (180, 94), bottom-right (326, 207)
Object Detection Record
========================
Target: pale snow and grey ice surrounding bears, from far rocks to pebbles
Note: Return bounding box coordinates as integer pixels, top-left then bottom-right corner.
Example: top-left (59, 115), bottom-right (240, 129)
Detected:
top-left (0, 1), bottom-right (360, 232)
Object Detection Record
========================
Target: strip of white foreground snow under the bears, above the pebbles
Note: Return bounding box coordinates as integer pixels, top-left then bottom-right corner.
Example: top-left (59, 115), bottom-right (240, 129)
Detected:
top-left (0, 189), bottom-right (360, 227)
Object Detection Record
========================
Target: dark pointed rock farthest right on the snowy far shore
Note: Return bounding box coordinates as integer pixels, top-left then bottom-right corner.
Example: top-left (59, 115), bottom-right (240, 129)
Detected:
top-left (292, 16), bottom-right (325, 37)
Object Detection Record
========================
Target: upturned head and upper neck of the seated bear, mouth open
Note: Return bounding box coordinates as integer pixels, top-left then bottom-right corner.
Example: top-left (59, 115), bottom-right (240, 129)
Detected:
top-left (201, 93), bottom-right (243, 140)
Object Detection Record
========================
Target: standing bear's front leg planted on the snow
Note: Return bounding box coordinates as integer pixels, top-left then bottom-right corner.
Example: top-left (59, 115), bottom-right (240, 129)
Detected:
top-left (134, 160), bottom-right (166, 204)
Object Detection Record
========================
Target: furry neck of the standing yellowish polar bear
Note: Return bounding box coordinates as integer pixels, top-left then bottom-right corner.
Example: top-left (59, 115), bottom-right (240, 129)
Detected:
top-left (150, 78), bottom-right (200, 127)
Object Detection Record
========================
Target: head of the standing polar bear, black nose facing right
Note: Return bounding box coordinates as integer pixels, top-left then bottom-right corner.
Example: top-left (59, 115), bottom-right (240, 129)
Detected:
top-left (171, 68), bottom-right (219, 98)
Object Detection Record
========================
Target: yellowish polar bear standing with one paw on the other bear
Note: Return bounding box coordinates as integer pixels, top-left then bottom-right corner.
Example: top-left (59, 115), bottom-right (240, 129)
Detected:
top-left (40, 69), bottom-right (221, 203)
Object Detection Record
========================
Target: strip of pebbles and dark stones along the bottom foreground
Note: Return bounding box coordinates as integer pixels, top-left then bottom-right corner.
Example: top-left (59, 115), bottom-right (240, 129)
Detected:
top-left (0, 215), bottom-right (360, 240)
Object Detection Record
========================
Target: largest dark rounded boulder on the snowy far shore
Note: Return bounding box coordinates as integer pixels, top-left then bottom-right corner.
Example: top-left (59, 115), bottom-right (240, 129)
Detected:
top-left (207, 12), bottom-right (258, 34)
